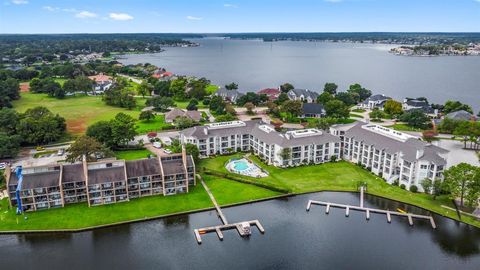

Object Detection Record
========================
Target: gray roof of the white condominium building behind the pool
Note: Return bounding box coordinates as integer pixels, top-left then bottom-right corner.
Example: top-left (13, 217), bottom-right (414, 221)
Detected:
top-left (181, 120), bottom-right (340, 147)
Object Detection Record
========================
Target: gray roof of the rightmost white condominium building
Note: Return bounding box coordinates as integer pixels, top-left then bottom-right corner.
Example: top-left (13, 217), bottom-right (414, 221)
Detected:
top-left (345, 122), bottom-right (448, 165)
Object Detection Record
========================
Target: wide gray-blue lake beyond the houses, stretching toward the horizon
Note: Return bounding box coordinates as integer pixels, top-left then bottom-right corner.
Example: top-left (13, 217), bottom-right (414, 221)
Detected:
top-left (121, 38), bottom-right (480, 110)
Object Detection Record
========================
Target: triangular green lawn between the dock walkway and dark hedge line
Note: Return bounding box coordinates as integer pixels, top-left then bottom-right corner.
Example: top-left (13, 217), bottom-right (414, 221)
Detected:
top-left (203, 175), bottom-right (281, 205)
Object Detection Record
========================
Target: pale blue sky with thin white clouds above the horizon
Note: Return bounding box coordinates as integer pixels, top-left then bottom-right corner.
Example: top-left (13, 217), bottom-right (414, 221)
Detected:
top-left (0, 0), bottom-right (480, 33)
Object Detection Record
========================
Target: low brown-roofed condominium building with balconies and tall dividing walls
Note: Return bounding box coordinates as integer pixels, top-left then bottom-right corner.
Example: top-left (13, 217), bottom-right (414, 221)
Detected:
top-left (5, 151), bottom-right (196, 211)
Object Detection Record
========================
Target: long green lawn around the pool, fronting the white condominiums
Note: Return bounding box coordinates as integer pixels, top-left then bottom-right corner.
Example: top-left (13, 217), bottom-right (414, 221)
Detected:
top-left (201, 154), bottom-right (480, 227)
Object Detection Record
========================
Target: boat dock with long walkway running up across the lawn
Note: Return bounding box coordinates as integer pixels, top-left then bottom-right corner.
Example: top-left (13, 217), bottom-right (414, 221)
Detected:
top-left (194, 175), bottom-right (265, 244)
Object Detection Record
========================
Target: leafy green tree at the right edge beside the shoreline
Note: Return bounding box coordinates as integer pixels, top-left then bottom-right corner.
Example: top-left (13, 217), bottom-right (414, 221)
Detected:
top-left (443, 163), bottom-right (480, 206)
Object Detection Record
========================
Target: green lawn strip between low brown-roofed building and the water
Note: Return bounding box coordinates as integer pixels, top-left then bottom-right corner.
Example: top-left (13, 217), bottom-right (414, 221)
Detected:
top-left (0, 185), bottom-right (213, 231)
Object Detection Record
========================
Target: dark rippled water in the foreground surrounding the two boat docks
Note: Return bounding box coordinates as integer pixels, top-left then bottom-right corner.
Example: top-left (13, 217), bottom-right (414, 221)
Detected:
top-left (0, 192), bottom-right (480, 270)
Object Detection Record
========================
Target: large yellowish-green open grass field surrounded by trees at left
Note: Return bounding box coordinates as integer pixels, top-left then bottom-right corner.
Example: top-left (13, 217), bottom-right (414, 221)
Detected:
top-left (13, 93), bottom-right (145, 134)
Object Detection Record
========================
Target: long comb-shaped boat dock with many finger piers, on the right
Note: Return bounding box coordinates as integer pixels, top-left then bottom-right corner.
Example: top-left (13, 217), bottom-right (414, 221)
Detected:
top-left (307, 187), bottom-right (437, 229)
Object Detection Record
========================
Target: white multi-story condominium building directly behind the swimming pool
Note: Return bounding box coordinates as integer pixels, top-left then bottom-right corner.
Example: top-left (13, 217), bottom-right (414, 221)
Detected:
top-left (180, 120), bottom-right (340, 167)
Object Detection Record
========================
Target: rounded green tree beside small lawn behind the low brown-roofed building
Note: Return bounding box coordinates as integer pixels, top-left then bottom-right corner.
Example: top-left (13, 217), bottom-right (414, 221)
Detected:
top-left (110, 113), bottom-right (137, 149)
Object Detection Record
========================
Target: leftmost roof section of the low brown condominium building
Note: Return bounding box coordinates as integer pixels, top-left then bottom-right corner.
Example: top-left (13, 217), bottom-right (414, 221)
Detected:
top-left (8, 170), bottom-right (60, 190)
